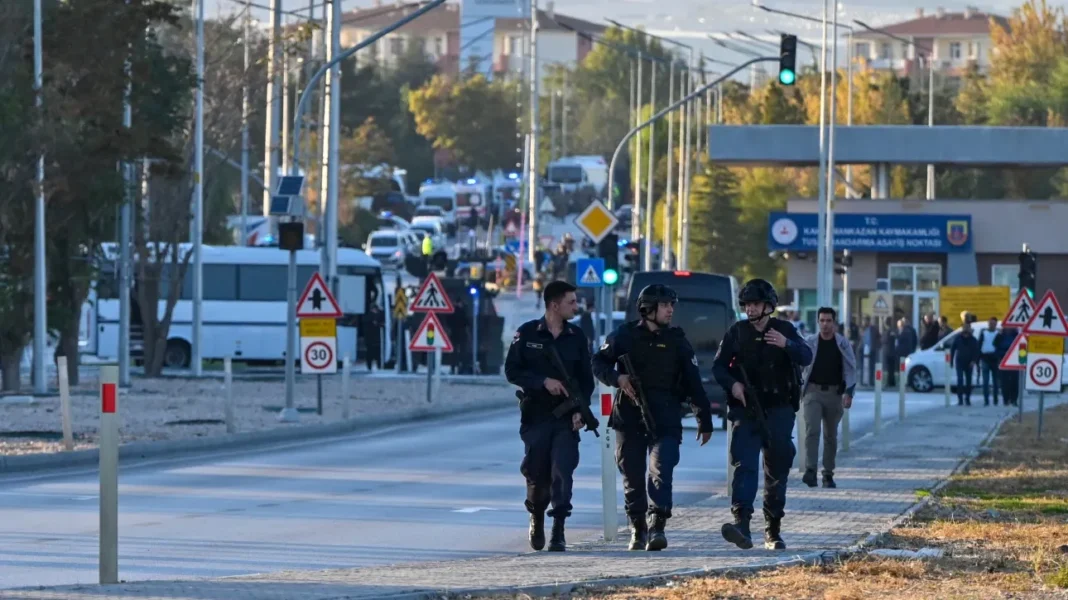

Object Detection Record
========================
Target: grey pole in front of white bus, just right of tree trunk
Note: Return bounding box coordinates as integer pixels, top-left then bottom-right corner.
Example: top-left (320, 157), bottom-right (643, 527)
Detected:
top-left (190, 0), bottom-right (206, 377)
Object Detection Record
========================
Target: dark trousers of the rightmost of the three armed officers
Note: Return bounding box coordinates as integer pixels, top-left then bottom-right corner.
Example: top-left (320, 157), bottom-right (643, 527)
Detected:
top-left (727, 406), bottom-right (797, 520)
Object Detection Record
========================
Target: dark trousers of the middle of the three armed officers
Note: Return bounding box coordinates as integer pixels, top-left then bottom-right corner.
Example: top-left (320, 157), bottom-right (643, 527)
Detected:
top-left (615, 430), bottom-right (682, 518)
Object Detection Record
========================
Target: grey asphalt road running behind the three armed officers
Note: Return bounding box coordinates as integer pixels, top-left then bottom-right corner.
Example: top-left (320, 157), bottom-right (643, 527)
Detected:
top-left (0, 384), bottom-right (948, 587)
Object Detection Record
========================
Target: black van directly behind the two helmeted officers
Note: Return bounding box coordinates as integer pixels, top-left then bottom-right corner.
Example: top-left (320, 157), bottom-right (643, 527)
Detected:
top-left (627, 271), bottom-right (737, 420)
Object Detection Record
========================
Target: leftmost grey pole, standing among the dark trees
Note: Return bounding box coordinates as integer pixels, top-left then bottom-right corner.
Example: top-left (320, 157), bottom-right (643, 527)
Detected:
top-left (33, 0), bottom-right (48, 394)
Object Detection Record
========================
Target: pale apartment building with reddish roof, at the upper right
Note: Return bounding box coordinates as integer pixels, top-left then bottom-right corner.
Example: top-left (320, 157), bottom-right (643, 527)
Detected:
top-left (853, 6), bottom-right (1007, 78)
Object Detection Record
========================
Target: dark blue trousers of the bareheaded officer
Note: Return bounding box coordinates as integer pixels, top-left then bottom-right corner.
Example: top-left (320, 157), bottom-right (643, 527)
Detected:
top-left (519, 419), bottom-right (579, 518)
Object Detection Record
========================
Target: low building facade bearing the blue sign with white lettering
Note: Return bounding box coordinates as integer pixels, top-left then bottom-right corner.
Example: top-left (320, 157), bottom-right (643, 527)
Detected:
top-left (768, 199), bottom-right (1068, 327)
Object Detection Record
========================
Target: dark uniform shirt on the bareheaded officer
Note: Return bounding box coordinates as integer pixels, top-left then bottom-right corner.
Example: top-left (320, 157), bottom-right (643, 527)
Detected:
top-left (504, 317), bottom-right (594, 423)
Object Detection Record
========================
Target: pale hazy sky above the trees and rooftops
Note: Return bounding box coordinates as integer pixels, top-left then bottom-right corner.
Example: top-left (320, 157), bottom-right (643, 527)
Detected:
top-left (203, 0), bottom-right (1029, 62)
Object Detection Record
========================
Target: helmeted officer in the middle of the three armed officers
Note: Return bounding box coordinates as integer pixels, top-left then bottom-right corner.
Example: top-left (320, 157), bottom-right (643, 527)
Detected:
top-left (593, 284), bottom-right (712, 551)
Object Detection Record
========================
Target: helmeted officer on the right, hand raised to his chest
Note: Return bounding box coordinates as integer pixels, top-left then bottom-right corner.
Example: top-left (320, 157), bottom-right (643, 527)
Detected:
top-left (712, 279), bottom-right (813, 550)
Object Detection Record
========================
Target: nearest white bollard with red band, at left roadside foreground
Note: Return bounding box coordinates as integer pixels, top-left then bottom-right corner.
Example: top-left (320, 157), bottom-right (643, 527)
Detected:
top-left (99, 365), bottom-right (119, 585)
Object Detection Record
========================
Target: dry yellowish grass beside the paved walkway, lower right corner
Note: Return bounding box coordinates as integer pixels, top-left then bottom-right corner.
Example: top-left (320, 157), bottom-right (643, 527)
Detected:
top-left (476, 406), bottom-right (1068, 600)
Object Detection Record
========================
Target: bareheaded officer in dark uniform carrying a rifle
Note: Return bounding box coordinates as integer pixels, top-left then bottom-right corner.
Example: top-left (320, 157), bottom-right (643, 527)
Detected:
top-left (504, 281), bottom-right (599, 552)
